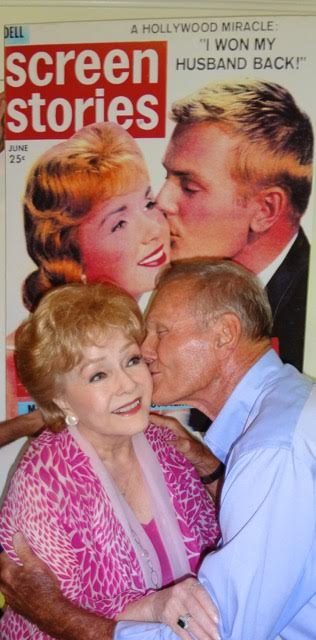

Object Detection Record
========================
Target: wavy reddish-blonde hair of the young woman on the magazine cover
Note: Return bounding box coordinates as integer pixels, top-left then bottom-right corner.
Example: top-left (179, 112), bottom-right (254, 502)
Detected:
top-left (23, 122), bottom-right (149, 310)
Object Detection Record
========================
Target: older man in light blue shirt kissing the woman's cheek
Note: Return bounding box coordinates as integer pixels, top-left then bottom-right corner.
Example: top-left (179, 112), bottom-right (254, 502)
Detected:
top-left (0, 259), bottom-right (316, 640)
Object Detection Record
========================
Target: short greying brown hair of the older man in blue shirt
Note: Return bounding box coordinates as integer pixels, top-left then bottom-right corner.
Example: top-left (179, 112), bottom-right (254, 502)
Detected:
top-left (157, 258), bottom-right (272, 341)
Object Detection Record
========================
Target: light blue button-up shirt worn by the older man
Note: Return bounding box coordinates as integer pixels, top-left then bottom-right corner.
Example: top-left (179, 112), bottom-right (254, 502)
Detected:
top-left (115, 350), bottom-right (316, 640)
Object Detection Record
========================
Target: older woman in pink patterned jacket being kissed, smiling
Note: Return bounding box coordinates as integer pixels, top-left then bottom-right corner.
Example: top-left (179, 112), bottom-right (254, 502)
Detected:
top-left (0, 284), bottom-right (218, 640)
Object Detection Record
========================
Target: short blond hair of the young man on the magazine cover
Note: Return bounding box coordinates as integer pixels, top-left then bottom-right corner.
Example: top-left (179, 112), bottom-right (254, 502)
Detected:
top-left (171, 80), bottom-right (313, 224)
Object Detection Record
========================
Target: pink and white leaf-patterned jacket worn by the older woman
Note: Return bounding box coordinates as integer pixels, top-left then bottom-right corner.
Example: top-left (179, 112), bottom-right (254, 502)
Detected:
top-left (0, 424), bottom-right (219, 640)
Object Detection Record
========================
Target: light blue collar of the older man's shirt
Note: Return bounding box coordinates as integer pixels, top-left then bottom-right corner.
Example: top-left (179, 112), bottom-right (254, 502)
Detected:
top-left (204, 349), bottom-right (283, 463)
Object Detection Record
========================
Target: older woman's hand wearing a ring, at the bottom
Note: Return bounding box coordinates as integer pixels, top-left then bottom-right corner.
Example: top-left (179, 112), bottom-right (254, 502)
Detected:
top-left (116, 578), bottom-right (219, 640)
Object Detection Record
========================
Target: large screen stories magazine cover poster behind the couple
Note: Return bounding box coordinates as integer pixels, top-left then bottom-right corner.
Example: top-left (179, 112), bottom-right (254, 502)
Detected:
top-left (5, 16), bottom-right (316, 417)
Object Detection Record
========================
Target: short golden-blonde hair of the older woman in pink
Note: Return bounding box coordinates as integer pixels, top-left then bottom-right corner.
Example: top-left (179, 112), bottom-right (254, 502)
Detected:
top-left (15, 283), bottom-right (144, 431)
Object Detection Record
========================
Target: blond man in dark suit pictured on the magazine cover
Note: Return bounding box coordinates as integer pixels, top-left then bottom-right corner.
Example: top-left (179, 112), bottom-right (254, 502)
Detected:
top-left (157, 80), bottom-right (313, 370)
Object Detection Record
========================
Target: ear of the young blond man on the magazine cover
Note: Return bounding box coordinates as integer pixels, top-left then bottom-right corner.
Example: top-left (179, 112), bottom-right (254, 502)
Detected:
top-left (250, 187), bottom-right (288, 233)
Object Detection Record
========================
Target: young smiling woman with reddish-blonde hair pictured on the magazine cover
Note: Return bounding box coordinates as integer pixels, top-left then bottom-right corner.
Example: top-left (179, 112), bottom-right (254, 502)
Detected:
top-left (7, 122), bottom-right (170, 417)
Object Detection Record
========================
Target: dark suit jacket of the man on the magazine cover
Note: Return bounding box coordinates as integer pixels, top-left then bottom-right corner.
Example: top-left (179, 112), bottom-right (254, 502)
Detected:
top-left (266, 228), bottom-right (310, 371)
